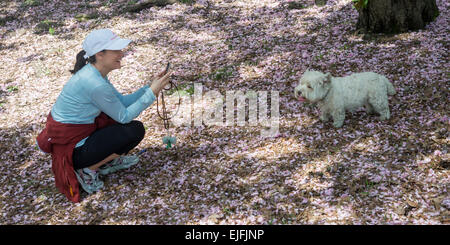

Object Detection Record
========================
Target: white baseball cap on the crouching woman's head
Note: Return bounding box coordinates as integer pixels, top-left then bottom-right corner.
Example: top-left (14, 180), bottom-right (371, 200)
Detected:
top-left (83, 29), bottom-right (131, 59)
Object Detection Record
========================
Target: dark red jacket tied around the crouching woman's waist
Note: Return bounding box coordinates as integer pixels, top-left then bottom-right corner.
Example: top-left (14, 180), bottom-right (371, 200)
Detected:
top-left (37, 112), bottom-right (117, 202)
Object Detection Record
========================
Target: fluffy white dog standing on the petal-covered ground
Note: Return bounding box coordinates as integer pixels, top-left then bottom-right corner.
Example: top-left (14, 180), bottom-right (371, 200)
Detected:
top-left (295, 70), bottom-right (395, 128)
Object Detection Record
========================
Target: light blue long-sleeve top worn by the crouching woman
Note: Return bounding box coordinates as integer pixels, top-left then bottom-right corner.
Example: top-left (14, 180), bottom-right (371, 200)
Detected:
top-left (44, 64), bottom-right (156, 147)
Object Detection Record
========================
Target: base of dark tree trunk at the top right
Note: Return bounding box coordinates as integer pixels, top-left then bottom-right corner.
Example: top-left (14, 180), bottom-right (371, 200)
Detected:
top-left (356, 0), bottom-right (439, 33)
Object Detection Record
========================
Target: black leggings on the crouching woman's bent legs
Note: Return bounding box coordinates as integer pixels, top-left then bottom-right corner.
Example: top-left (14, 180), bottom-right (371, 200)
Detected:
top-left (72, 121), bottom-right (145, 169)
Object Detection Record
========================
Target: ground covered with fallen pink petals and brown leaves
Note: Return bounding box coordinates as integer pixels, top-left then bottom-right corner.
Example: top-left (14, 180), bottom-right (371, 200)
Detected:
top-left (0, 0), bottom-right (450, 224)
